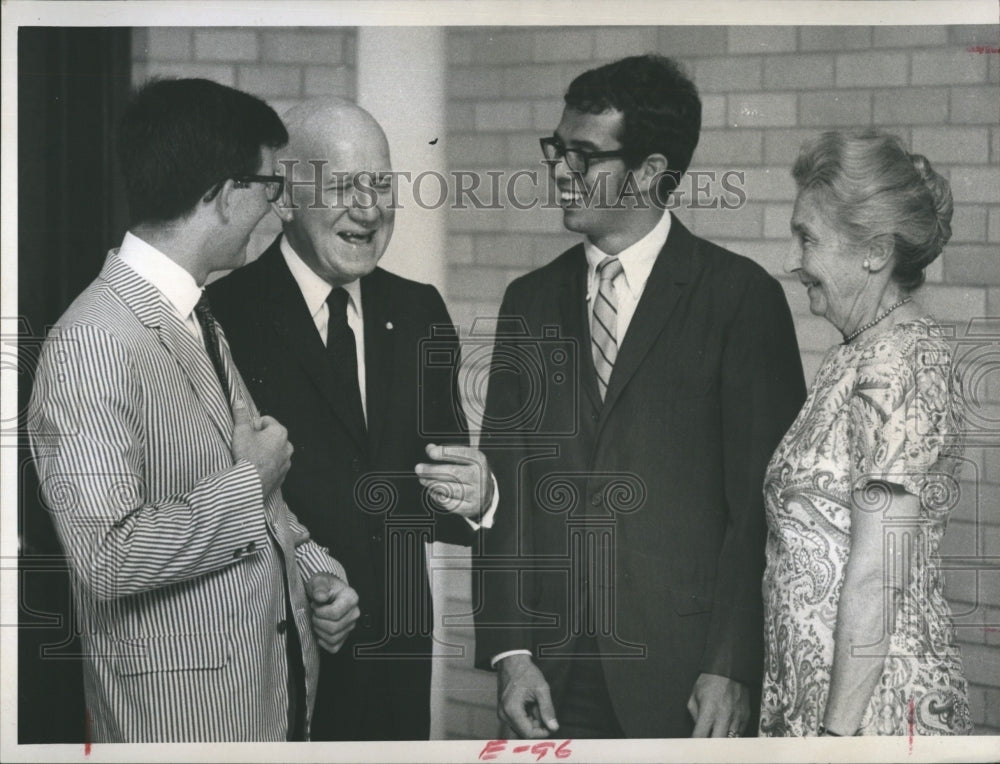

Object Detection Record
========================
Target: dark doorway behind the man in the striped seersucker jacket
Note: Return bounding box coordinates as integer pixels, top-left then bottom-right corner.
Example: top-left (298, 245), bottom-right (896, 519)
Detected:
top-left (17, 27), bottom-right (132, 743)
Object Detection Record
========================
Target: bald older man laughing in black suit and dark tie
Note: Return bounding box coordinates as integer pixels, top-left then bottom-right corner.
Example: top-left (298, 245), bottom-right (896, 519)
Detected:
top-left (209, 98), bottom-right (495, 740)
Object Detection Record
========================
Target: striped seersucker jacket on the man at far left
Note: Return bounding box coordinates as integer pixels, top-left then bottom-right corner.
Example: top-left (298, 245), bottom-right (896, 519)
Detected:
top-left (28, 251), bottom-right (346, 742)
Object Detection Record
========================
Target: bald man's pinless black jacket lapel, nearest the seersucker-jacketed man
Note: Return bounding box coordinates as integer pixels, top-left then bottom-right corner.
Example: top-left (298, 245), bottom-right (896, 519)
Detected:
top-left (261, 237), bottom-right (368, 451)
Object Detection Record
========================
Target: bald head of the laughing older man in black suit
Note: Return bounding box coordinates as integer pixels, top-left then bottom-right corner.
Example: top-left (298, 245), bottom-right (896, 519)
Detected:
top-left (277, 97), bottom-right (395, 287)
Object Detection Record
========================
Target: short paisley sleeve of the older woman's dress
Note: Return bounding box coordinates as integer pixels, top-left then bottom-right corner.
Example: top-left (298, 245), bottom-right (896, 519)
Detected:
top-left (849, 324), bottom-right (960, 504)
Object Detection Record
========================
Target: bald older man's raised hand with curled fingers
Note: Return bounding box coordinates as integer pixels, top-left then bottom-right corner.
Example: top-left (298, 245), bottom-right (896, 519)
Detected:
top-left (416, 443), bottom-right (493, 522)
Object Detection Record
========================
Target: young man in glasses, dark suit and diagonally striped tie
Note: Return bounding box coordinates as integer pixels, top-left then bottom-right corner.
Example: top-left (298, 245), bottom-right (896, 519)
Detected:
top-left (473, 56), bottom-right (805, 738)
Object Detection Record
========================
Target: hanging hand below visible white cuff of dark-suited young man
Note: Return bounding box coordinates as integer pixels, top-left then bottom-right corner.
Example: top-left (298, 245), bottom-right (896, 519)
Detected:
top-left (497, 655), bottom-right (559, 738)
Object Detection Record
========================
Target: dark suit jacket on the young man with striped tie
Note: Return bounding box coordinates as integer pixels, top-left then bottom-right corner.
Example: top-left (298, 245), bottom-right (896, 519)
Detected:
top-left (473, 213), bottom-right (805, 737)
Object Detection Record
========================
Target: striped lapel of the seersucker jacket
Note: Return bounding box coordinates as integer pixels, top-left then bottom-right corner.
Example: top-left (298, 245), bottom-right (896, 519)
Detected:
top-left (101, 253), bottom-right (233, 446)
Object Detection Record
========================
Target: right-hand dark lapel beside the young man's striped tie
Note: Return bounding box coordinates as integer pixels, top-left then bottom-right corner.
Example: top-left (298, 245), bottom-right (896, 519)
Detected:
top-left (601, 218), bottom-right (695, 420)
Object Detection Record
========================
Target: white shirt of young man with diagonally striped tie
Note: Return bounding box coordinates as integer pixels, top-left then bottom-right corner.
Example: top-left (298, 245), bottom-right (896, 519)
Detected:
top-left (490, 210), bottom-right (670, 666)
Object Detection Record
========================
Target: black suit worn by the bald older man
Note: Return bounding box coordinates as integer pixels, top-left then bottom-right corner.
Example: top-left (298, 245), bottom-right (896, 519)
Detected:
top-left (208, 240), bottom-right (472, 740)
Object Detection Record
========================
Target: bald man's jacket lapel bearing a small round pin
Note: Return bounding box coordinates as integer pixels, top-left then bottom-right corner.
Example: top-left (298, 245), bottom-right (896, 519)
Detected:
top-left (361, 270), bottom-right (398, 456)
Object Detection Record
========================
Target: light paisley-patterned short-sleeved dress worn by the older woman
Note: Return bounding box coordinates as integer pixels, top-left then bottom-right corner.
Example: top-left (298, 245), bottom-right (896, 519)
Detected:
top-left (760, 319), bottom-right (972, 736)
